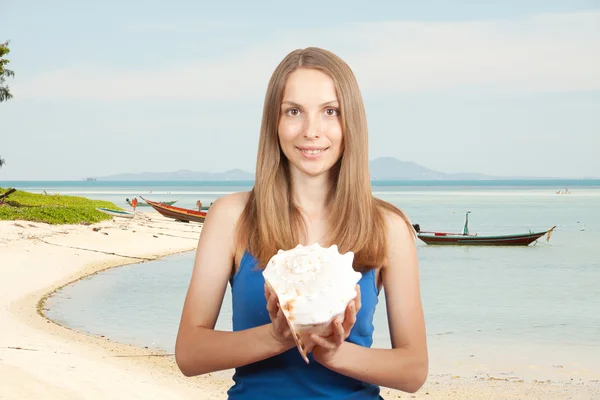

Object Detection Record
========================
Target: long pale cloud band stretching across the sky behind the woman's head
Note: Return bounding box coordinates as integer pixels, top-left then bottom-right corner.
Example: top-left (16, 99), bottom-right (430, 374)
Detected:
top-left (14, 11), bottom-right (600, 101)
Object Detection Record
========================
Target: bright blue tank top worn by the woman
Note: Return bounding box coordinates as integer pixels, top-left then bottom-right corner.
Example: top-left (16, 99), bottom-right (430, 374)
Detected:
top-left (227, 252), bottom-right (382, 400)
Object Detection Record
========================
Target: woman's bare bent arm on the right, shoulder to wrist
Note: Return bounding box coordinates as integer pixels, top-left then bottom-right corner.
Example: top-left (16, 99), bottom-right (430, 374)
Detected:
top-left (316, 214), bottom-right (429, 393)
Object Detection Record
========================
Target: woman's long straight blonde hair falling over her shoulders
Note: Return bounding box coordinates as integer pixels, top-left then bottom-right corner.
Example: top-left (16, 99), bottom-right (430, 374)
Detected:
top-left (237, 47), bottom-right (410, 270)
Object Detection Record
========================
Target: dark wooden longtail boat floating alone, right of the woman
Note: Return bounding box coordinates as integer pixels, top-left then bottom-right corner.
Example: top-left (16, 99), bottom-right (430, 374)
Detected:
top-left (413, 211), bottom-right (556, 246)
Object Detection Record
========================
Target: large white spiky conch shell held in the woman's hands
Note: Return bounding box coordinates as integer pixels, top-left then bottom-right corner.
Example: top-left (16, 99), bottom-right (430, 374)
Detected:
top-left (263, 243), bottom-right (362, 364)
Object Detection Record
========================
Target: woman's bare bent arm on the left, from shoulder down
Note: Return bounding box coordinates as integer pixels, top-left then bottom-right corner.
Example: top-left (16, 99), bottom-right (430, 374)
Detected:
top-left (175, 193), bottom-right (294, 376)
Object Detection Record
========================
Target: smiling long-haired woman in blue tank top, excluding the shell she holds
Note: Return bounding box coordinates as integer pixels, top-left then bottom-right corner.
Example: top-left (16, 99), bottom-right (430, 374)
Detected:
top-left (175, 47), bottom-right (428, 400)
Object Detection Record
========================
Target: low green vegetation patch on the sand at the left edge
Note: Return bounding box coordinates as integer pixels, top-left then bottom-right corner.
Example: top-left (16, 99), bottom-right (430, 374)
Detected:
top-left (0, 188), bottom-right (120, 225)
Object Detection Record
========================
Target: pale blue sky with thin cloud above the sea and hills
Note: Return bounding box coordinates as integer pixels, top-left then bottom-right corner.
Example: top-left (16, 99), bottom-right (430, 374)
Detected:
top-left (0, 0), bottom-right (600, 182)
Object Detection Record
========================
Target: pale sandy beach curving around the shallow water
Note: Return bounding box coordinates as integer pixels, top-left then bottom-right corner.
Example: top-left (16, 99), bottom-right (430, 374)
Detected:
top-left (0, 213), bottom-right (600, 400)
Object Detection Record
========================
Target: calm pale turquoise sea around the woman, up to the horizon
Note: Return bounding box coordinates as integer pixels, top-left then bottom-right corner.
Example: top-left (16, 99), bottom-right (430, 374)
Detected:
top-left (5, 179), bottom-right (600, 381)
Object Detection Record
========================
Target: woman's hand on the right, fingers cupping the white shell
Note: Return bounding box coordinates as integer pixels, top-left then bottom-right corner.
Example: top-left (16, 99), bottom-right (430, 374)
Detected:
top-left (310, 285), bottom-right (362, 365)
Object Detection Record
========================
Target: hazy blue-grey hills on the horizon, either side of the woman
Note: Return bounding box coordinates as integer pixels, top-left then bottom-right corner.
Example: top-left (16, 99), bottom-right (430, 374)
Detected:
top-left (87, 157), bottom-right (580, 181)
